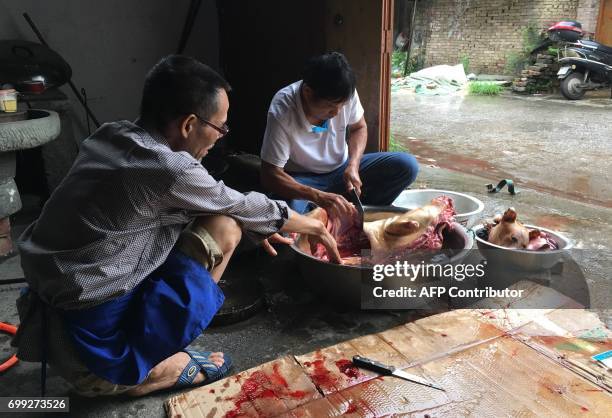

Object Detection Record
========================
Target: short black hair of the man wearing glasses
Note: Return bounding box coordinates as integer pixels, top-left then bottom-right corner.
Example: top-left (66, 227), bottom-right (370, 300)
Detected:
top-left (140, 55), bottom-right (231, 129)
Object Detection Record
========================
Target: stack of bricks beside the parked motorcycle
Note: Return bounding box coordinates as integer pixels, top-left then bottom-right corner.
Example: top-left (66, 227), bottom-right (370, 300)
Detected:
top-left (512, 54), bottom-right (559, 93)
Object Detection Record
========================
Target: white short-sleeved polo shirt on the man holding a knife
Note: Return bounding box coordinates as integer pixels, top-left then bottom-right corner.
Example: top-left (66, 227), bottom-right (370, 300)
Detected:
top-left (261, 80), bottom-right (363, 173)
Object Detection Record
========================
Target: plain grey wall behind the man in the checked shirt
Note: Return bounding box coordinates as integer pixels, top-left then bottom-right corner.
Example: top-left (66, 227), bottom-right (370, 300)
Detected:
top-left (0, 0), bottom-right (219, 139)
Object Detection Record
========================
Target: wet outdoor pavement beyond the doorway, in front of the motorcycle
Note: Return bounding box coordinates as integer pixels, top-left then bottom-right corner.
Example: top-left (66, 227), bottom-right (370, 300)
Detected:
top-left (391, 90), bottom-right (612, 208)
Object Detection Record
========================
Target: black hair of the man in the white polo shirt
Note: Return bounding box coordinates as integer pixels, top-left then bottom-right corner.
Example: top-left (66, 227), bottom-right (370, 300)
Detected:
top-left (302, 52), bottom-right (356, 102)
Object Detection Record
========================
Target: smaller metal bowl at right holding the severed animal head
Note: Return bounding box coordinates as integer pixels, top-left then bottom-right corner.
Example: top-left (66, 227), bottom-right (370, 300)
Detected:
top-left (472, 225), bottom-right (573, 272)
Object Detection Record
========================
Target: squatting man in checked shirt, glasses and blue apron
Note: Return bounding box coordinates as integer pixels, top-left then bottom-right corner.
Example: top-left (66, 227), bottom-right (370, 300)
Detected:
top-left (14, 56), bottom-right (339, 396)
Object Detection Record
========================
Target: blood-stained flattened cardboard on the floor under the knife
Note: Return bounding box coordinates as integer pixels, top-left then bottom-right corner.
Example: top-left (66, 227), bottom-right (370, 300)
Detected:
top-left (165, 285), bottom-right (612, 418)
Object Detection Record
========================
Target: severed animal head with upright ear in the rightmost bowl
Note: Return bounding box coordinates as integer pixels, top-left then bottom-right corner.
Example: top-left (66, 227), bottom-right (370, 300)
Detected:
top-left (485, 208), bottom-right (559, 251)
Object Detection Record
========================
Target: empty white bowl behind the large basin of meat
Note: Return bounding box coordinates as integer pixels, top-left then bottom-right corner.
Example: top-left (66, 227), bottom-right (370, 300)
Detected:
top-left (392, 189), bottom-right (484, 228)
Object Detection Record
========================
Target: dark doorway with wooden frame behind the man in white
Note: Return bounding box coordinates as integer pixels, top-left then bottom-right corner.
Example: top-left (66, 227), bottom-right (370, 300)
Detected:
top-left (217, 0), bottom-right (394, 155)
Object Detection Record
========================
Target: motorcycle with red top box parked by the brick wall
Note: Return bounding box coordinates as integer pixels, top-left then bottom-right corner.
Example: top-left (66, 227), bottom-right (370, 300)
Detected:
top-left (548, 21), bottom-right (612, 100)
